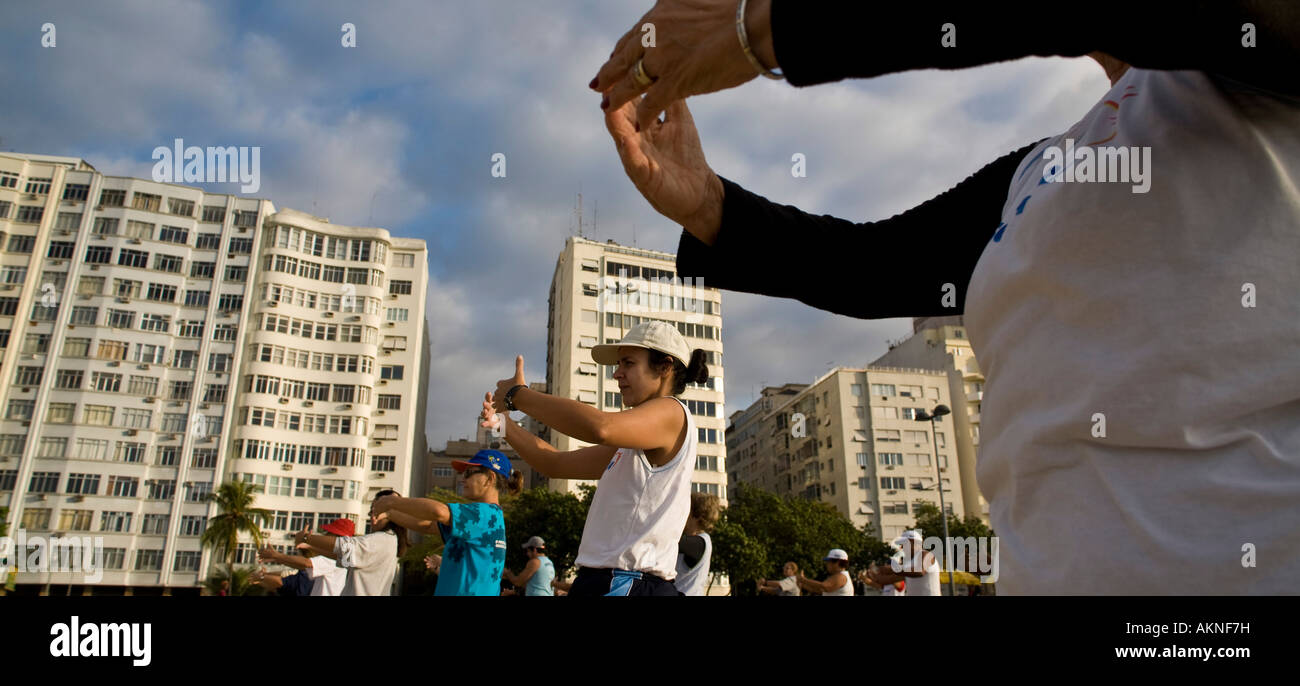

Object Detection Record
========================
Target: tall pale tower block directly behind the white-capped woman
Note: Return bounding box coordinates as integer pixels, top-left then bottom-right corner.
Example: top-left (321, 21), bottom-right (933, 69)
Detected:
top-left (546, 236), bottom-right (727, 502)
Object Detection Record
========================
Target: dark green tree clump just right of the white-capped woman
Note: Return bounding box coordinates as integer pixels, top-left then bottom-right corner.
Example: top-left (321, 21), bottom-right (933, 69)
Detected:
top-left (712, 486), bottom-right (892, 595)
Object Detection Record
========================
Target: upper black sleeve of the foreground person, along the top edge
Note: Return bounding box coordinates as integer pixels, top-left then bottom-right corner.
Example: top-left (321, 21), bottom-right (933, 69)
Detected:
top-left (771, 0), bottom-right (1300, 95)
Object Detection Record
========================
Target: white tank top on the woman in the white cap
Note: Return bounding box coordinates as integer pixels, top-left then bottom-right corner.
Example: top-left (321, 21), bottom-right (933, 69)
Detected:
top-left (577, 398), bottom-right (699, 581)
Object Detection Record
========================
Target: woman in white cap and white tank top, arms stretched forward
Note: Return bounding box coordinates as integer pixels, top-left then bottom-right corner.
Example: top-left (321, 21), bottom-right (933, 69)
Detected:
top-left (484, 321), bottom-right (709, 596)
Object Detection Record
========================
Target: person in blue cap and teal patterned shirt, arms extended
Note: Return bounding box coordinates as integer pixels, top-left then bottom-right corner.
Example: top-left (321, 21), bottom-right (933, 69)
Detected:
top-left (374, 450), bottom-right (523, 595)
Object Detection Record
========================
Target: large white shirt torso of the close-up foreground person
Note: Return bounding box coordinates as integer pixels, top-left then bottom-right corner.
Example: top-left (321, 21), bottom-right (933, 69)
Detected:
top-left (967, 69), bottom-right (1300, 595)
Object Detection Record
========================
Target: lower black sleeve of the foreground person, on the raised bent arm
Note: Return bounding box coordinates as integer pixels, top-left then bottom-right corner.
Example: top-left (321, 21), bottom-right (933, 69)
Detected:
top-left (677, 143), bottom-right (1037, 320)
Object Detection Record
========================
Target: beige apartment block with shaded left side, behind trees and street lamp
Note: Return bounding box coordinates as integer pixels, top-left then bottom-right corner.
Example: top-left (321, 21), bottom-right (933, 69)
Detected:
top-left (727, 366), bottom-right (963, 540)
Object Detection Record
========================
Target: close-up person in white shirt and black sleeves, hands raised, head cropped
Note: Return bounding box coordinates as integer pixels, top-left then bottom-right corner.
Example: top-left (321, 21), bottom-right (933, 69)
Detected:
top-left (590, 0), bottom-right (1300, 595)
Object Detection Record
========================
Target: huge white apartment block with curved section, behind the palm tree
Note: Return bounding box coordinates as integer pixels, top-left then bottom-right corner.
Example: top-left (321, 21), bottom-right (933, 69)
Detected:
top-left (0, 153), bottom-right (428, 592)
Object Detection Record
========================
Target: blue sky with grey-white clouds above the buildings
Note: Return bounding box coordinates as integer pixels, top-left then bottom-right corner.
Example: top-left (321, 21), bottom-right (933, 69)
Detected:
top-left (0, 0), bottom-right (1108, 448)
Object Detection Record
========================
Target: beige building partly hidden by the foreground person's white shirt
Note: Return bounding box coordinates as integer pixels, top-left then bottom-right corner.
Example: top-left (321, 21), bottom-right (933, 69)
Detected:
top-left (871, 317), bottom-right (988, 524)
